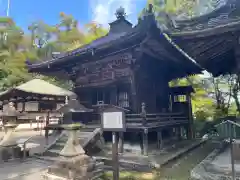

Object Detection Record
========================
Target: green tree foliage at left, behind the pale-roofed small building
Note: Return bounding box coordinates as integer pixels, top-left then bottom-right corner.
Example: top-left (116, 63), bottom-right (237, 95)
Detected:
top-left (0, 13), bottom-right (107, 91)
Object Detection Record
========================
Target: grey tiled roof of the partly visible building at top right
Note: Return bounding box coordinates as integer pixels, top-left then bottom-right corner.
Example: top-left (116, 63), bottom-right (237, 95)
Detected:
top-left (168, 0), bottom-right (240, 36)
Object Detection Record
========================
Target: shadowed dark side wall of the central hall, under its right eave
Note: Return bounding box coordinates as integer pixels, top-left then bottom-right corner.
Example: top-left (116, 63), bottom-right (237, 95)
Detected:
top-left (135, 56), bottom-right (169, 113)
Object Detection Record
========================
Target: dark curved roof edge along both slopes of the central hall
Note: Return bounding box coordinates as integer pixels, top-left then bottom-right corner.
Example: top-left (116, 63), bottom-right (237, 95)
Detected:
top-left (28, 11), bottom-right (203, 76)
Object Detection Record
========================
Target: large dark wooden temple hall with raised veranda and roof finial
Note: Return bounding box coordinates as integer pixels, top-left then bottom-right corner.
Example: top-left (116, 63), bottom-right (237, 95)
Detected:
top-left (27, 6), bottom-right (202, 154)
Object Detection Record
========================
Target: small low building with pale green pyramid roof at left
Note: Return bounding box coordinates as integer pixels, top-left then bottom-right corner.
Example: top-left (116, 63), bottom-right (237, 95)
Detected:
top-left (0, 79), bottom-right (76, 123)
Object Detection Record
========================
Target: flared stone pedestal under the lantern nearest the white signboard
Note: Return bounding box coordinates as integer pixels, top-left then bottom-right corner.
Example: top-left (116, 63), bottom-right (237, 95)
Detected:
top-left (43, 125), bottom-right (103, 180)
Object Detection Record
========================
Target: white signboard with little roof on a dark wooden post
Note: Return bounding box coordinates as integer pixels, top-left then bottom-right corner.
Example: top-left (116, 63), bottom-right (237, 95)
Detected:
top-left (101, 106), bottom-right (126, 180)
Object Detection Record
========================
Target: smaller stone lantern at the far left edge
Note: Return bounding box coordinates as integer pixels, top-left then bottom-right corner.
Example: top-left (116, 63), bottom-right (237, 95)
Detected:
top-left (0, 103), bottom-right (21, 161)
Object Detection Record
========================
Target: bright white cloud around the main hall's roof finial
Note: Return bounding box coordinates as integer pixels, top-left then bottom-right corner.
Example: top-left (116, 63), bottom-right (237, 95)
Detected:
top-left (90, 0), bottom-right (142, 26)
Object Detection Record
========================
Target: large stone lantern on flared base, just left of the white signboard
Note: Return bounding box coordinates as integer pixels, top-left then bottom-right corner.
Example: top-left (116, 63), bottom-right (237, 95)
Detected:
top-left (43, 99), bottom-right (102, 180)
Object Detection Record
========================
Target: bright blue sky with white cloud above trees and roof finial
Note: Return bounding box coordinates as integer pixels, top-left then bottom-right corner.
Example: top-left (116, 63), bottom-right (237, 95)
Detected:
top-left (0, 0), bottom-right (147, 29)
